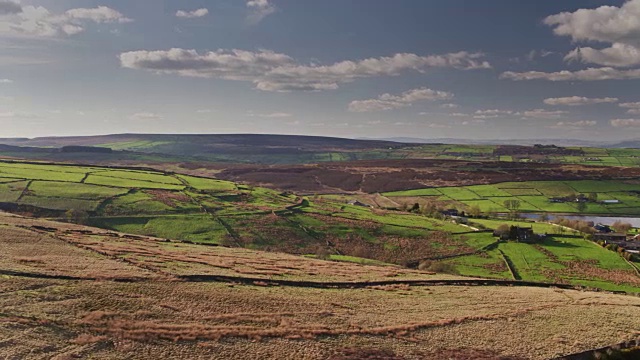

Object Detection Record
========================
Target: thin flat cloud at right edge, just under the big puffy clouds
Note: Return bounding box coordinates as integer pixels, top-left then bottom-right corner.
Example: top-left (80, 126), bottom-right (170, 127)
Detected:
top-left (500, 67), bottom-right (640, 81)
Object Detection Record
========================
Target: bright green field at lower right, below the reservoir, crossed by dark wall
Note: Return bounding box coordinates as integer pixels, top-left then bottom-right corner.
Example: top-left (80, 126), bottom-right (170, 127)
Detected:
top-left (443, 219), bottom-right (640, 292)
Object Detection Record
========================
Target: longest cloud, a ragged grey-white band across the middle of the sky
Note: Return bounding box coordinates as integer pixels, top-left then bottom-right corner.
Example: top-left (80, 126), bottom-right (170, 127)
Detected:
top-left (120, 48), bottom-right (490, 91)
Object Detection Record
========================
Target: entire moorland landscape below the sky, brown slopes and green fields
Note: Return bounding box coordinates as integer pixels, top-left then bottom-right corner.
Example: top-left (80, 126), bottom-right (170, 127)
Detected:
top-left (0, 135), bottom-right (640, 359)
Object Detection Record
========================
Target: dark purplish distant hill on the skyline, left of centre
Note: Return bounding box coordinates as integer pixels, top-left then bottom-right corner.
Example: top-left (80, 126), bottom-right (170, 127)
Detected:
top-left (0, 134), bottom-right (414, 164)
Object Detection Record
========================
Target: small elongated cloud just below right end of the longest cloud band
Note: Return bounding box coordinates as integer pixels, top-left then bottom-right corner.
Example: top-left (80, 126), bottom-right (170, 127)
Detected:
top-left (349, 88), bottom-right (453, 112)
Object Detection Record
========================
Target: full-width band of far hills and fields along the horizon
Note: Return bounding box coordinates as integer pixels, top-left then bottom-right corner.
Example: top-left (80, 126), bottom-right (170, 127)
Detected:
top-left (0, 134), bottom-right (640, 167)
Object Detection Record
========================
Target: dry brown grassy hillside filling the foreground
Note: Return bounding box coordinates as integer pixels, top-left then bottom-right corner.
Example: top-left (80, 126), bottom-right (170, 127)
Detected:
top-left (0, 214), bottom-right (640, 360)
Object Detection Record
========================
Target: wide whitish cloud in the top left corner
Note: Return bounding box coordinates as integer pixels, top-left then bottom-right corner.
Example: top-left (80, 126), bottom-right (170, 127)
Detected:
top-left (0, 6), bottom-right (132, 37)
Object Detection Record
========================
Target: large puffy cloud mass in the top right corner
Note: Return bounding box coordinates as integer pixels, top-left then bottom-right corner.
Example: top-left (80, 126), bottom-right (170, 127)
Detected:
top-left (544, 0), bottom-right (640, 67)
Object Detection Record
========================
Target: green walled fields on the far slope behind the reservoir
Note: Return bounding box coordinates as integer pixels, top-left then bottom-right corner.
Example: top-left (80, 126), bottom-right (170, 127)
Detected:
top-left (384, 180), bottom-right (640, 215)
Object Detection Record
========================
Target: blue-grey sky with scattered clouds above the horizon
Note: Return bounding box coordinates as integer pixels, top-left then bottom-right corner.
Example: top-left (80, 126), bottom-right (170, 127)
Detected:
top-left (0, 0), bottom-right (640, 141)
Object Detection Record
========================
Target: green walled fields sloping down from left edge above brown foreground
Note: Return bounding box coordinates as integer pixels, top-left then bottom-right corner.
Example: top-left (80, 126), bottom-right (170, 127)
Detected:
top-left (0, 162), bottom-right (483, 263)
